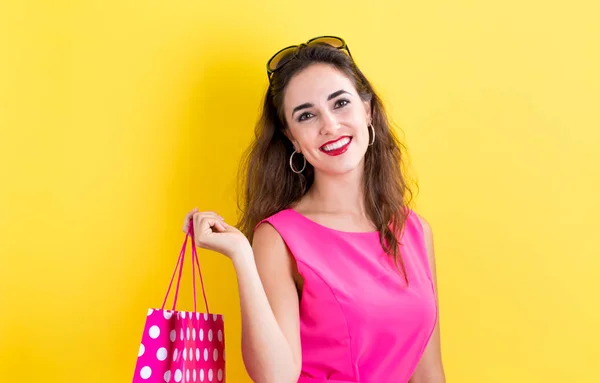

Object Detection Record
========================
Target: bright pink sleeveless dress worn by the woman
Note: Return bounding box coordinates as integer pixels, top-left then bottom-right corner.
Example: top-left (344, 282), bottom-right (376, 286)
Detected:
top-left (257, 209), bottom-right (438, 383)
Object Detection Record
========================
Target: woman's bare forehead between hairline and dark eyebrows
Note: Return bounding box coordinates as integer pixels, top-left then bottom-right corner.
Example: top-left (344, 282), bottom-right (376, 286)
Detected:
top-left (284, 64), bottom-right (356, 110)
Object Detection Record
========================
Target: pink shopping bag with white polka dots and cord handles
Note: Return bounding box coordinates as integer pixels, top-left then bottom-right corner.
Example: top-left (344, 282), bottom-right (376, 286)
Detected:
top-left (133, 224), bottom-right (225, 383)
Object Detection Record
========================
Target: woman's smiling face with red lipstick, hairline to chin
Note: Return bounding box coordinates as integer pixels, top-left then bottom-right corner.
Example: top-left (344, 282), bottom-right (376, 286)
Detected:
top-left (283, 64), bottom-right (371, 174)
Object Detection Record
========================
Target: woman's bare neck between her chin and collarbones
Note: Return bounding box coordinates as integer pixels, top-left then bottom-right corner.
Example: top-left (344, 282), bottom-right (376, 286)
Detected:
top-left (305, 162), bottom-right (366, 216)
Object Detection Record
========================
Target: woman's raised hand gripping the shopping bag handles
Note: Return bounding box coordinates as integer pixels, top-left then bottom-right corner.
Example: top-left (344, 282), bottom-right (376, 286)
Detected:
top-left (183, 208), bottom-right (252, 259)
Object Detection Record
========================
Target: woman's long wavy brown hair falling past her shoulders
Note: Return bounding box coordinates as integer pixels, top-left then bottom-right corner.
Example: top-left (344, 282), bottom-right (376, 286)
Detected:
top-left (238, 44), bottom-right (413, 283)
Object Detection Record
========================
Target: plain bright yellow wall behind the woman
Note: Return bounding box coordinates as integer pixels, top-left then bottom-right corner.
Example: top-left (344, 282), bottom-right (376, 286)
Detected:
top-left (0, 0), bottom-right (600, 383)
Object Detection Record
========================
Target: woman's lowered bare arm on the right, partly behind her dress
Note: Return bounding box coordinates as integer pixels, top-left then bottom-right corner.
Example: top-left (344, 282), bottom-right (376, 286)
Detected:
top-left (409, 217), bottom-right (446, 383)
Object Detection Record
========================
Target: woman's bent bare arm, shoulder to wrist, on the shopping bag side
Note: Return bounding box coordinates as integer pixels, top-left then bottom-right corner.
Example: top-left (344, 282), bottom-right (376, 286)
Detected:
top-left (232, 223), bottom-right (302, 383)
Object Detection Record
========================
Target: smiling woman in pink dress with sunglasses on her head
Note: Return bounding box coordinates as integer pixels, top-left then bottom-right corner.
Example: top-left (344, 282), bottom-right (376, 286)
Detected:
top-left (183, 37), bottom-right (445, 383)
